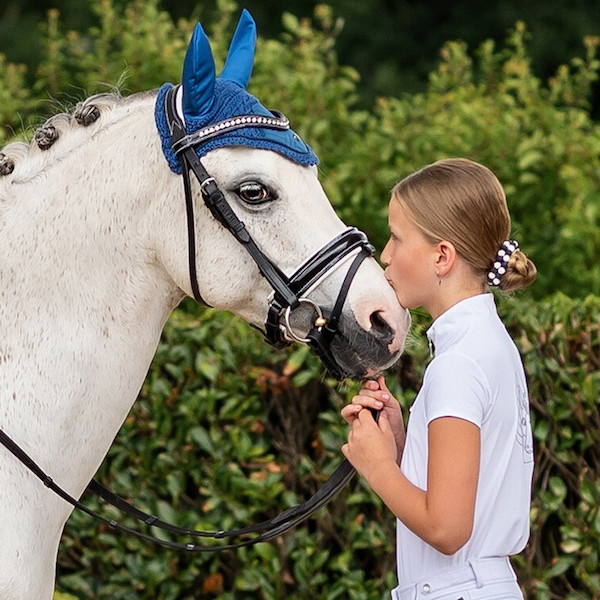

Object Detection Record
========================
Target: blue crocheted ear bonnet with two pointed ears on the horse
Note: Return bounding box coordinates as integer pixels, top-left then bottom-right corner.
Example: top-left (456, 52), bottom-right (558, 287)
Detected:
top-left (155, 10), bottom-right (319, 173)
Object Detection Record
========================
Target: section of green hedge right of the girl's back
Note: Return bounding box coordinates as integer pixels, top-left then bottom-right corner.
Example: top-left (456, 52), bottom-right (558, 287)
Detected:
top-left (508, 295), bottom-right (600, 599)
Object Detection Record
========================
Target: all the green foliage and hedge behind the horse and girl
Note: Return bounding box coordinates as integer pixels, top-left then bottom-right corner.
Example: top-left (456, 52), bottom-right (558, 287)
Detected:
top-left (0, 0), bottom-right (600, 600)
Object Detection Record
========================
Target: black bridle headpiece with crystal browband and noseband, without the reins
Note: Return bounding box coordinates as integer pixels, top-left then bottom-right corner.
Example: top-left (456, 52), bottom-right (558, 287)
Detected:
top-left (165, 86), bottom-right (374, 380)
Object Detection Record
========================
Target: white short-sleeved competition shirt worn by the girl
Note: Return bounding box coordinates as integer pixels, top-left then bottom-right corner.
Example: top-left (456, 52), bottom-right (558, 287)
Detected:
top-left (396, 294), bottom-right (533, 585)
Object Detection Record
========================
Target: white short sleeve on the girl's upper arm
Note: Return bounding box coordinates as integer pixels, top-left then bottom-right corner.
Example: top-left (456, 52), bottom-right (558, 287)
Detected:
top-left (423, 352), bottom-right (490, 428)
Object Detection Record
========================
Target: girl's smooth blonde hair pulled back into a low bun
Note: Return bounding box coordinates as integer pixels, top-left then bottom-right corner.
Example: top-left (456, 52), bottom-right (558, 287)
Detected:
top-left (392, 158), bottom-right (537, 291)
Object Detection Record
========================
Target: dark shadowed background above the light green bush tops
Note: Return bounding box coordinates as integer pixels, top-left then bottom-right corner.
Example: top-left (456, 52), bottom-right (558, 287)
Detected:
top-left (0, 0), bottom-right (600, 114)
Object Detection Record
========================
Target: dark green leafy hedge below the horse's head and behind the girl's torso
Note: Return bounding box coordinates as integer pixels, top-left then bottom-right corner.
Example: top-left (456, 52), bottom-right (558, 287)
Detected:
top-left (58, 295), bottom-right (600, 600)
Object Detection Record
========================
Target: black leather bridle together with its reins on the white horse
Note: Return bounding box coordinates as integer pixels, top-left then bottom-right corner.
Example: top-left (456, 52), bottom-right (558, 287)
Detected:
top-left (0, 88), bottom-right (378, 552)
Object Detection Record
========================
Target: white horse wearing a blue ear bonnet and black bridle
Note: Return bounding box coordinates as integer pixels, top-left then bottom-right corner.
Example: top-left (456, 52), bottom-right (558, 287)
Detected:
top-left (0, 11), bottom-right (409, 600)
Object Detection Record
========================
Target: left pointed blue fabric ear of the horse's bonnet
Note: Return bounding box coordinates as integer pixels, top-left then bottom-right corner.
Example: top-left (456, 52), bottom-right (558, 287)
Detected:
top-left (182, 23), bottom-right (215, 117)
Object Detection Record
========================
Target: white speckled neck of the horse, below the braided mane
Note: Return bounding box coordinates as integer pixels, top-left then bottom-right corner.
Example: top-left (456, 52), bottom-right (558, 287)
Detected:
top-left (0, 94), bottom-right (185, 600)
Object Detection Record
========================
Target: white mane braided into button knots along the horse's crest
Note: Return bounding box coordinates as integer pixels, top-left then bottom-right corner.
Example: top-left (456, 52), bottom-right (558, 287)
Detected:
top-left (0, 91), bottom-right (156, 182)
